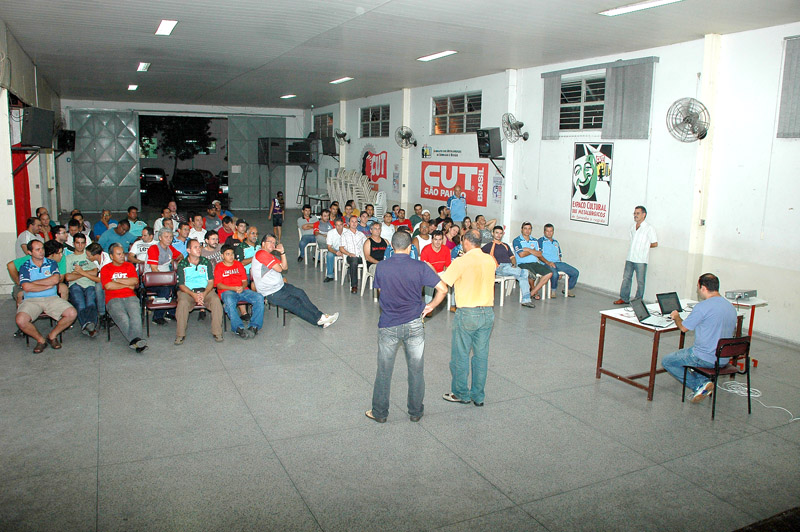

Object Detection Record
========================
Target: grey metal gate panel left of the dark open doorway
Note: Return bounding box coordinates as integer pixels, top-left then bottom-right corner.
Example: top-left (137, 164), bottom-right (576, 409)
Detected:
top-left (70, 110), bottom-right (141, 212)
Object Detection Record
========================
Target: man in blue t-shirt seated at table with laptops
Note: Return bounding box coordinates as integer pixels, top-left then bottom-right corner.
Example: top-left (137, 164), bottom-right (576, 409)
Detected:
top-left (661, 273), bottom-right (736, 403)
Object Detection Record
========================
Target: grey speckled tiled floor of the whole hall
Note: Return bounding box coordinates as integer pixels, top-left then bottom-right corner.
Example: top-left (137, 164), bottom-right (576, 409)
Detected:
top-left (0, 213), bottom-right (800, 532)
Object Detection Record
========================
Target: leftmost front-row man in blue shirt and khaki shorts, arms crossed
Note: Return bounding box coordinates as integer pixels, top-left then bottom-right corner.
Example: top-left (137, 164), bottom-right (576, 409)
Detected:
top-left (16, 239), bottom-right (78, 353)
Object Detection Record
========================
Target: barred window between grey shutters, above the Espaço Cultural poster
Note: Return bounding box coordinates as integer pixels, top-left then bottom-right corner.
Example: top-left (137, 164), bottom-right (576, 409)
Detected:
top-left (558, 76), bottom-right (606, 131)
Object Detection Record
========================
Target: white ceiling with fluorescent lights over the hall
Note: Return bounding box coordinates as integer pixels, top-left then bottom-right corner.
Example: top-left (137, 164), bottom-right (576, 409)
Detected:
top-left (0, 0), bottom-right (800, 108)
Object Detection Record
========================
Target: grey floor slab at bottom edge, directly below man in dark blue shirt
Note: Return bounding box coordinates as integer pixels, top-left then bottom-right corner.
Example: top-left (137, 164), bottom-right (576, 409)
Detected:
top-left (273, 424), bottom-right (511, 531)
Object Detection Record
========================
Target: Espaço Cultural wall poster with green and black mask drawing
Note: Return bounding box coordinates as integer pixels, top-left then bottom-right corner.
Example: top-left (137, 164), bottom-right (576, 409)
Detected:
top-left (569, 142), bottom-right (614, 225)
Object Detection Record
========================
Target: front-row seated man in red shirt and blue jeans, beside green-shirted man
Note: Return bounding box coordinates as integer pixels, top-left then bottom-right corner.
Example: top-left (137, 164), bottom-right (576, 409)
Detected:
top-left (214, 244), bottom-right (264, 338)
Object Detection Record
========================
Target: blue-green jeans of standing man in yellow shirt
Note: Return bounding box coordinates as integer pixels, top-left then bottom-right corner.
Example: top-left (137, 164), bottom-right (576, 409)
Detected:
top-left (450, 308), bottom-right (494, 403)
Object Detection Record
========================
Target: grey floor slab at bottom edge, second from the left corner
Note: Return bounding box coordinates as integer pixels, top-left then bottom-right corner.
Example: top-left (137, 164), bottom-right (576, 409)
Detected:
top-left (98, 443), bottom-right (319, 531)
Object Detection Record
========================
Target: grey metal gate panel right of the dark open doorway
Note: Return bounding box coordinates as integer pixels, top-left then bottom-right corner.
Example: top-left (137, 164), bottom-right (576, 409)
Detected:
top-left (228, 116), bottom-right (286, 210)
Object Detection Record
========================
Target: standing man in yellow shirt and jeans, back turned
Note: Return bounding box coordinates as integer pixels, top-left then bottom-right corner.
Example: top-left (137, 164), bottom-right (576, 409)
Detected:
top-left (440, 229), bottom-right (496, 406)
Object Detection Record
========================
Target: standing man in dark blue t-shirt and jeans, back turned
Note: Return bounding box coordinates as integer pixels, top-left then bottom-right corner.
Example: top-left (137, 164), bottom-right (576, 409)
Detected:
top-left (365, 231), bottom-right (447, 423)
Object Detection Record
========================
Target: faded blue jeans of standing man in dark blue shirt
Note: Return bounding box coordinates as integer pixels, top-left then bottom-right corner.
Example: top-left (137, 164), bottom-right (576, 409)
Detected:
top-left (372, 318), bottom-right (425, 418)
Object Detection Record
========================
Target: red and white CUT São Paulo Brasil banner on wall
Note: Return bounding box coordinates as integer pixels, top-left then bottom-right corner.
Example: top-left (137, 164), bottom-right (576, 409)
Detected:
top-left (421, 161), bottom-right (489, 207)
